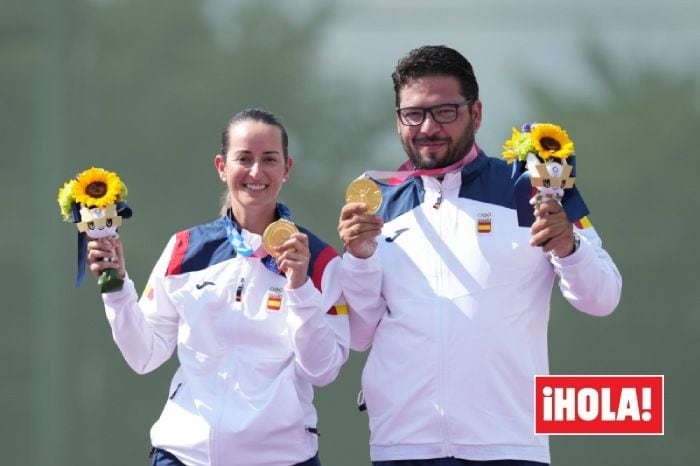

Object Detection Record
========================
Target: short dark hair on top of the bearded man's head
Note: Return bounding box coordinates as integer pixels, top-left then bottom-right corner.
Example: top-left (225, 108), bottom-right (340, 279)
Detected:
top-left (391, 45), bottom-right (479, 107)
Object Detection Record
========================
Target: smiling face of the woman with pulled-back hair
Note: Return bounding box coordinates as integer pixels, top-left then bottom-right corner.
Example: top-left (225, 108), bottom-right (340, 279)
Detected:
top-left (214, 120), bottom-right (292, 212)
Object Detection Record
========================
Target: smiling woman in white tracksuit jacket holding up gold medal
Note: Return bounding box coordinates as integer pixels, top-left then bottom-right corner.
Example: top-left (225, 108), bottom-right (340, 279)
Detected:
top-left (88, 109), bottom-right (349, 466)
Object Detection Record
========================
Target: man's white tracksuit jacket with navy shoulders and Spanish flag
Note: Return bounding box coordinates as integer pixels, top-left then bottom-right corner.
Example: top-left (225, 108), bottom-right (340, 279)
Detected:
top-left (343, 153), bottom-right (621, 462)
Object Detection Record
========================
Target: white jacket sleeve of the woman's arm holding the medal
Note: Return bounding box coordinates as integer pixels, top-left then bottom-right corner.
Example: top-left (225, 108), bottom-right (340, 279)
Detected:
top-left (285, 256), bottom-right (350, 386)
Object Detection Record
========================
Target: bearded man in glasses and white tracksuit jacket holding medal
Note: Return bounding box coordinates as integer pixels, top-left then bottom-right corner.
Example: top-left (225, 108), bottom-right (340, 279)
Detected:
top-left (338, 46), bottom-right (621, 466)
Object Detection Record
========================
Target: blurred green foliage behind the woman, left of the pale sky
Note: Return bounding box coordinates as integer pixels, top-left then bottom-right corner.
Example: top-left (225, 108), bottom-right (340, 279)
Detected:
top-left (0, 0), bottom-right (382, 466)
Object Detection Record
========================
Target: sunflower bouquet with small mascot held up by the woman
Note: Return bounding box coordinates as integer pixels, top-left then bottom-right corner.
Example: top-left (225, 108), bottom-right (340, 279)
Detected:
top-left (58, 167), bottom-right (132, 293)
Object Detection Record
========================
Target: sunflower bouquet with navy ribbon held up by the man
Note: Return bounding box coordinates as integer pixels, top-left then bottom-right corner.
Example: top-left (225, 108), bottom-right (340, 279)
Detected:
top-left (503, 123), bottom-right (588, 226)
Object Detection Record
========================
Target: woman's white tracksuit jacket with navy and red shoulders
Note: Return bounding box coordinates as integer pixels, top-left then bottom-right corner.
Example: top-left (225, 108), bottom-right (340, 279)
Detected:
top-left (103, 212), bottom-right (350, 466)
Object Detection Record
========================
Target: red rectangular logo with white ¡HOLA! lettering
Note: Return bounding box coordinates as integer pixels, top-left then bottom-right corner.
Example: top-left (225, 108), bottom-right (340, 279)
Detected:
top-left (535, 375), bottom-right (664, 435)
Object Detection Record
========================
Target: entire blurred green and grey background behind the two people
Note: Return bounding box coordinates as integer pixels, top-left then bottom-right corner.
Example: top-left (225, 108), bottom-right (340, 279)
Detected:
top-left (0, 0), bottom-right (700, 466)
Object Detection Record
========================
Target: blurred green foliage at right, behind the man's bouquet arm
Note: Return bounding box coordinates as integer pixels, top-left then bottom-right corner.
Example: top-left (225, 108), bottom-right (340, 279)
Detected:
top-left (525, 44), bottom-right (700, 466)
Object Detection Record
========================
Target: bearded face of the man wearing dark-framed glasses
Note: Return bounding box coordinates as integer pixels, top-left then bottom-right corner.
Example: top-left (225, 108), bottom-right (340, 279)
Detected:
top-left (396, 76), bottom-right (481, 168)
